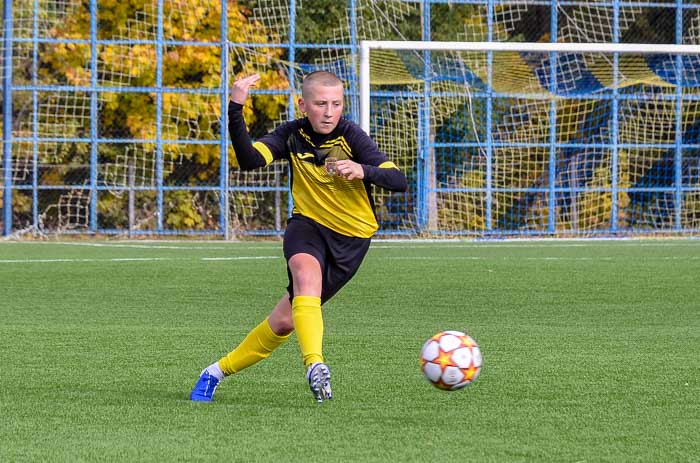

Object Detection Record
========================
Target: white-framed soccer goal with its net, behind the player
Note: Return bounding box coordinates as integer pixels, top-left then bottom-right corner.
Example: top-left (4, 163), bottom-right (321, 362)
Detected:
top-left (360, 41), bottom-right (700, 236)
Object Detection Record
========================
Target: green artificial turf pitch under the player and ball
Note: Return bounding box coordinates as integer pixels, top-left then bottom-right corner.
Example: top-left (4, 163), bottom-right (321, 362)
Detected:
top-left (0, 240), bottom-right (700, 462)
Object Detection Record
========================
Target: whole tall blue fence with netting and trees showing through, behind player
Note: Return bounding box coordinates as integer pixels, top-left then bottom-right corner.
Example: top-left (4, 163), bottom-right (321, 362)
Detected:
top-left (0, 0), bottom-right (700, 238)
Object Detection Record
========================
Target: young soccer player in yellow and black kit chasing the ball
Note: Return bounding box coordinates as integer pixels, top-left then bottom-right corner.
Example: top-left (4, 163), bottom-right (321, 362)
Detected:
top-left (190, 71), bottom-right (407, 403)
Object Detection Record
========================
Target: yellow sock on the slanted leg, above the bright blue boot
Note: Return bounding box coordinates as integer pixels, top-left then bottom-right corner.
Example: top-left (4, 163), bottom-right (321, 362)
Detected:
top-left (219, 318), bottom-right (291, 376)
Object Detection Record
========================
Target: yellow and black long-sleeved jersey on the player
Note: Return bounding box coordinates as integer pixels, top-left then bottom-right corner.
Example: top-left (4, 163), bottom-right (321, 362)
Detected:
top-left (229, 102), bottom-right (407, 238)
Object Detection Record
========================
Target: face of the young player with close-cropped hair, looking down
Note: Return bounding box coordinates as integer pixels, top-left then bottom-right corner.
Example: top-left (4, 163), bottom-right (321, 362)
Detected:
top-left (299, 84), bottom-right (343, 135)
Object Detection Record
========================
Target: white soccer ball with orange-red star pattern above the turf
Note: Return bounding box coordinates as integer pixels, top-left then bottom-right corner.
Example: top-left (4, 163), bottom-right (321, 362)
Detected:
top-left (420, 331), bottom-right (481, 391)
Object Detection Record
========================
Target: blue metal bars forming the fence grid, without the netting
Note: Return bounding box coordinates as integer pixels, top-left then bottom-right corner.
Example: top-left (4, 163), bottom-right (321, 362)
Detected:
top-left (2, 0), bottom-right (700, 238)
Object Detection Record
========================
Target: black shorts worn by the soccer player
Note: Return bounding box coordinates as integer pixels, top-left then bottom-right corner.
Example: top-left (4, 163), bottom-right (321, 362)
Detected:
top-left (283, 215), bottom-right (370, 303)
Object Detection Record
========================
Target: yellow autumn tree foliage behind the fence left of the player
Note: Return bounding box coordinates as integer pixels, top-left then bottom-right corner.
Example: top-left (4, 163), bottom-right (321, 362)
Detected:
top-left (34, 0), bottom-right (288, 229)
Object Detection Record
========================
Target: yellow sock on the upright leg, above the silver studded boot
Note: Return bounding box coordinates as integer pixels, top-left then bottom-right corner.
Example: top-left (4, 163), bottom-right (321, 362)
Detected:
top-left (292, 296), bottom-right (323, 368)
